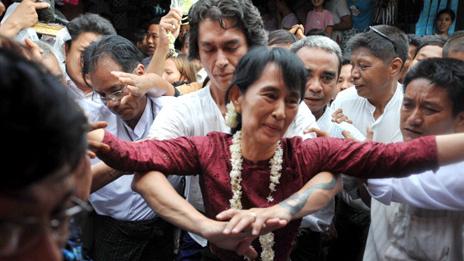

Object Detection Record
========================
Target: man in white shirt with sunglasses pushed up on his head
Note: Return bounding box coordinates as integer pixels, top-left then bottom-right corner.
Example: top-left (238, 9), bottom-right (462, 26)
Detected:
top-left (332, 25), bottom-right (408, 260)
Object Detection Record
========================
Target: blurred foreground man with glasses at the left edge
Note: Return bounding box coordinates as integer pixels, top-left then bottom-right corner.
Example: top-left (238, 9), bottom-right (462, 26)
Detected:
top-left (0, 49), bottom-right (90, 261)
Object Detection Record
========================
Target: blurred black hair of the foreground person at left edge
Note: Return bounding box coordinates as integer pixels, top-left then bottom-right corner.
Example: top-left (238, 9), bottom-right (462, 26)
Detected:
top-left (0, 48), bottom-right (88, 191)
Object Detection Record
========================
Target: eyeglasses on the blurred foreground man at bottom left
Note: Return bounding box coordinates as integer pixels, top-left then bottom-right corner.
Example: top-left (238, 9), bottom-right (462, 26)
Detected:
top-left (0, 197), bottom-right (92, 257)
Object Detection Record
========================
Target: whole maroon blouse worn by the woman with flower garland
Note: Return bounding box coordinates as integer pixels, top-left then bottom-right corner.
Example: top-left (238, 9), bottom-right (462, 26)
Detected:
top-left (98, 132), bottom-right (438, 261)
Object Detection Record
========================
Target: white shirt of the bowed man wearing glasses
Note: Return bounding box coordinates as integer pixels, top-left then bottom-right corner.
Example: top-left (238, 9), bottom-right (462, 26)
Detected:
top-left (80, 94), bottom-right (178, 221)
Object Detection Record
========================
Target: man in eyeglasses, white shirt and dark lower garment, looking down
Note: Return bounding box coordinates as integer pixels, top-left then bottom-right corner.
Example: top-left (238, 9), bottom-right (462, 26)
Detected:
top-left (81, 36), bottom-right (180, 261)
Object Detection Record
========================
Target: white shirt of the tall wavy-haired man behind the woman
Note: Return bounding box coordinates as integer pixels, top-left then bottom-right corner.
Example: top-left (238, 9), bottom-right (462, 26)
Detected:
top-left (150, 85), bottom-right (317, 246)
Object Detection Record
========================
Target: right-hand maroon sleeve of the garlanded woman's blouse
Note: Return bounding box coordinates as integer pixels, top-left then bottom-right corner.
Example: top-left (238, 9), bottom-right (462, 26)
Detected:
top-left (301, 136), bottom-right (438, 178)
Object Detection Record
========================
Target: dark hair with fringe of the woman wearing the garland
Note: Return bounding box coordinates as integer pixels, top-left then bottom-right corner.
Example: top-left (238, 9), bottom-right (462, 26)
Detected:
top-left (225, 47), bottom-right (307, 132)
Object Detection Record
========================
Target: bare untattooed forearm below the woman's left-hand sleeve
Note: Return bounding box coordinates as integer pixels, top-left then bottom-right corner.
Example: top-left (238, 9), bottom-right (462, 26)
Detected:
top-left (133, 171), bottom-right (210, 235)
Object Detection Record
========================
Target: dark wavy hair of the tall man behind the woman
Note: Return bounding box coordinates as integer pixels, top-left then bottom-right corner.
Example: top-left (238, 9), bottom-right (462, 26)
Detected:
top-left (189, 0), bottom-right (267, 60)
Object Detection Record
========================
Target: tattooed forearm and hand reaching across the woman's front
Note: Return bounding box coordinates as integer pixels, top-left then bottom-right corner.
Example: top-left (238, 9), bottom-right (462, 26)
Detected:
top-left (217, 172), bottom-right (341, 235)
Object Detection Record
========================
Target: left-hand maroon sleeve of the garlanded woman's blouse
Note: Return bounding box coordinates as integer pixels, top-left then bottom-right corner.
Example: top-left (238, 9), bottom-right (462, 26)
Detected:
top-left (97, 131), bottom-right (207, 175)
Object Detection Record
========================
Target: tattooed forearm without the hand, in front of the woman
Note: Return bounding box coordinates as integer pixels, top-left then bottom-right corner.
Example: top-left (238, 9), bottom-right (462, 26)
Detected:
top-left (278, 172), bottom-right (342, 219)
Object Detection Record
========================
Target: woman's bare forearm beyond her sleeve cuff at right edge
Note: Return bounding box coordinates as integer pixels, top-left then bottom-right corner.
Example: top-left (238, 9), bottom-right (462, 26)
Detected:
top-left (436, 133), bottom-right (464, 165)
